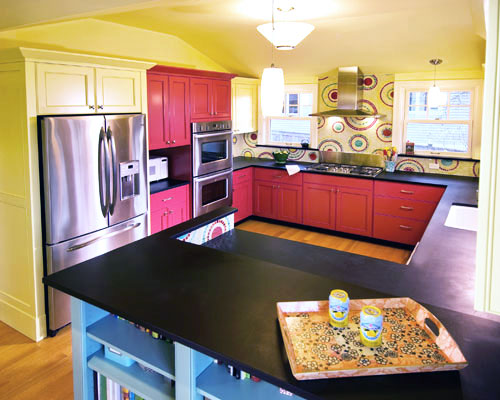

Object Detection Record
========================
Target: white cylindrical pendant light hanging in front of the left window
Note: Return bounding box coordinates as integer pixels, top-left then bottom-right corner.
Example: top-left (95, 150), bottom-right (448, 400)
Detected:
top-left (260, 0), bottom-right (285, 117)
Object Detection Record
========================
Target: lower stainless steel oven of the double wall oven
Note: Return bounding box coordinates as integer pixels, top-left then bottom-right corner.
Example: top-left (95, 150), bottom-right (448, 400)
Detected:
top-left (193, 169), bottom-right (233, 217)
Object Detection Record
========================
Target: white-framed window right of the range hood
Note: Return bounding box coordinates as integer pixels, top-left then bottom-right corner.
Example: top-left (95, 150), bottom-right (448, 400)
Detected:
top-left (393, 81), bottom-right (481, 158)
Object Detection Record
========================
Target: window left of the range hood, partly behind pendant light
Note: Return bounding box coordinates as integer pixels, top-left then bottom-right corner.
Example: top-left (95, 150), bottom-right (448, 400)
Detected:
top-left (260, 85), bottom-right (318, 148)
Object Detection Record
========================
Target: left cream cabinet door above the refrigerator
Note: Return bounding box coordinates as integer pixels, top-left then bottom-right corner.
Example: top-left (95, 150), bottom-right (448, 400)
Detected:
top-left (36, 63), bottom-right (96, 114)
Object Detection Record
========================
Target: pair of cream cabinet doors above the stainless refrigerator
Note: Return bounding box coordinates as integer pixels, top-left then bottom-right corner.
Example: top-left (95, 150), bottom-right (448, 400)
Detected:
top-left (36, 63), bottom-right (142, 114)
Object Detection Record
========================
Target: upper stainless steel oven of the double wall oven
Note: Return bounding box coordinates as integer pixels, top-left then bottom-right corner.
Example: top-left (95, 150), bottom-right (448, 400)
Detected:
top-left (193, 131), bottom-right (233, 176)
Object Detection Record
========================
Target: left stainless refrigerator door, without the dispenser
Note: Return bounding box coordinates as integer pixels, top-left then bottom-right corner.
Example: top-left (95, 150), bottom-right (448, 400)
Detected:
top-left (41, 116), bottom-right (109, 244)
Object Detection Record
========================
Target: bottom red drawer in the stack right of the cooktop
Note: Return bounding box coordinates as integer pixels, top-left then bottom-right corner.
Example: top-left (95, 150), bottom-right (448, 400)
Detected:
top-left (373, 214), bottom-right (427, 245)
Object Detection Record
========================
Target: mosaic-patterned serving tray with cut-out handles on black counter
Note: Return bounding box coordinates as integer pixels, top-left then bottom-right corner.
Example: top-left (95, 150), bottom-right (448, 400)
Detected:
top-left (277, 297), bottom-right (467, 380)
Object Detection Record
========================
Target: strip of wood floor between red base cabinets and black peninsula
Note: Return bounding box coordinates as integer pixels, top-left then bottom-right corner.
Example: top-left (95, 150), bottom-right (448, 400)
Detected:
top-left (236, 220), bottom-right (411, 264)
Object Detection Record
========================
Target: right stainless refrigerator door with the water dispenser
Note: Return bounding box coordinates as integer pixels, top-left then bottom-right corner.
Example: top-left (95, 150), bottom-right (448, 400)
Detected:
top-left (105, 115), bottom-right (148, 225)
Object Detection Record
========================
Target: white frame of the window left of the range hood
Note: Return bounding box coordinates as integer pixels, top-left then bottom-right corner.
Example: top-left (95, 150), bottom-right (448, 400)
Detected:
top-left (259, 84), bottom-right (318, 148)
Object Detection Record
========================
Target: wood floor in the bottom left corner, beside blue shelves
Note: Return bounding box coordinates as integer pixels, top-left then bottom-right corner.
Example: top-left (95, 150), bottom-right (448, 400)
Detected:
top-left (0, 322), bottom-right (73, 400)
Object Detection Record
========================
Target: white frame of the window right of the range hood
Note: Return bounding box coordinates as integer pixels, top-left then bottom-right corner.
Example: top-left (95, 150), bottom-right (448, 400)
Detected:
top-left (392, 79), bottom-right (483, 159)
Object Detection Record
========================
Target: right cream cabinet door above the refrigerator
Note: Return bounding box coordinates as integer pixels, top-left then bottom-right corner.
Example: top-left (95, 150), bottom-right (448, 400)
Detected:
top-left (95, 68), bottom-right (141, 113)
